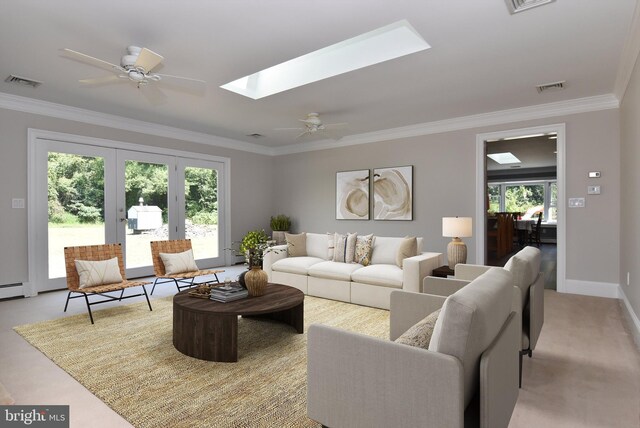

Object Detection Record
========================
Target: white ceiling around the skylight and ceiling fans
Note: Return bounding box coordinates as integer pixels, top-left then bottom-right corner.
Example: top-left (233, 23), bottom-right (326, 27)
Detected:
top-left (0, 0), bottom-right (637, 148)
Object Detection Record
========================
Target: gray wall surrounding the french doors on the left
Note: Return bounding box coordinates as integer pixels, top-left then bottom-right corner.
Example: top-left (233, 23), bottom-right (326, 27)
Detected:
top-left (0, 109), bottom-right (274, 285)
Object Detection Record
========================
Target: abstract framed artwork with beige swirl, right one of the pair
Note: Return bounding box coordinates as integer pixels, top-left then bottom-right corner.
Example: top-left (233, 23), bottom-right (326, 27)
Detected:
top-left (373, 165), bottom-right (413, 220)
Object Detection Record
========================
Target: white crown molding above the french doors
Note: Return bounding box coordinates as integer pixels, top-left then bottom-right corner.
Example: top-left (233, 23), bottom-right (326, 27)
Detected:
top-left (0, 93), bottom-right (273, 156)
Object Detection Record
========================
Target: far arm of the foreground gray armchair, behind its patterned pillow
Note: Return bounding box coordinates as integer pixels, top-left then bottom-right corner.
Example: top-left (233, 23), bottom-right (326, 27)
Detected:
top-left (389, 290), bottom-right (446, 340)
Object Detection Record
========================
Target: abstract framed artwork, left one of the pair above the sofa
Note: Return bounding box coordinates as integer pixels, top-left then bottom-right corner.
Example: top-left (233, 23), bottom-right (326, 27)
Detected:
top-left (336, 169), bottom-right (370, 220)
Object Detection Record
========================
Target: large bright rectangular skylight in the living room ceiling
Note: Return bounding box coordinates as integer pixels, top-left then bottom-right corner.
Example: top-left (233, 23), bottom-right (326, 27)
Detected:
top-left (220, 19), bottom-right (431, 100)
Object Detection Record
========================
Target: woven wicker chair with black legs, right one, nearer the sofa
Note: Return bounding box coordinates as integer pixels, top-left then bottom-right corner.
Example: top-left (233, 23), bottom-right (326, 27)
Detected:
top-left (151, 239), bottom-right (224, 295)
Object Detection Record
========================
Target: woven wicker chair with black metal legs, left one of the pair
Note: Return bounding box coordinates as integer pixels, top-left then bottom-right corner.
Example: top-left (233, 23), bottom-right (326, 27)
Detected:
top-left (64, 244), bottom-right (153, 324)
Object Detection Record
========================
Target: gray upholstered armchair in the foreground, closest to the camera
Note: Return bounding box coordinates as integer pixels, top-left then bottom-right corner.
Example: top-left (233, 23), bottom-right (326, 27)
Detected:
top-left (307, 268), bottom-right (520, 428)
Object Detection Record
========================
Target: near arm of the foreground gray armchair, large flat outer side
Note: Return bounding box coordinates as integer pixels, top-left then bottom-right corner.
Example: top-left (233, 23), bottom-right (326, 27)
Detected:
top-left (307, 324), bottom-right (464, 428)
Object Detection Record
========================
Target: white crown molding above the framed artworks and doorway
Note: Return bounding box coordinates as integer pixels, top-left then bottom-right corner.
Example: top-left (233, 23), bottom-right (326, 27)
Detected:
top-left (273, 94), bottom-right (620, 156)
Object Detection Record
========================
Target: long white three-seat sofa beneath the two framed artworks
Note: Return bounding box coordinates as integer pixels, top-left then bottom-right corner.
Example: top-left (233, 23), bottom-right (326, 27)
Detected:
top-left (263, 233), bottom-right (443, 309)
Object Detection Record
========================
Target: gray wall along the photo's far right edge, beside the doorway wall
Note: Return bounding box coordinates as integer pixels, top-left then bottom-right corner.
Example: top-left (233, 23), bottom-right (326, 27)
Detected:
top-left (620, 52), bottom-right (640, 316)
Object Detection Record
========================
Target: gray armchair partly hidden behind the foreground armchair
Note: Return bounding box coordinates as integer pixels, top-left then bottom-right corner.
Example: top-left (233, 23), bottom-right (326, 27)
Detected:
top-left (422, 247), bottom-right (544, 386)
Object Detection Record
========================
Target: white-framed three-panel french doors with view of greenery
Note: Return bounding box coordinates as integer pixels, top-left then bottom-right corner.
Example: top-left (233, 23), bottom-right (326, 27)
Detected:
top-left (30, 140), bottom-right (225, 291)
